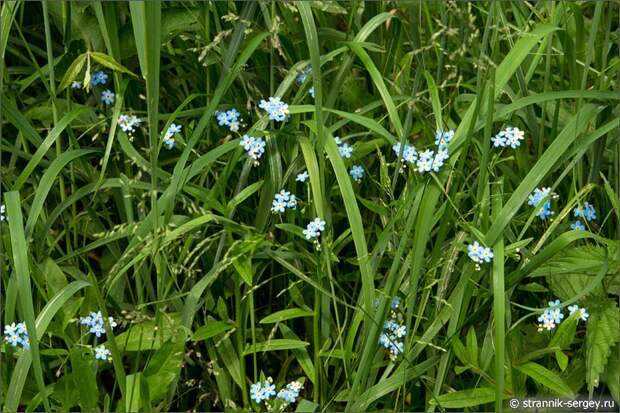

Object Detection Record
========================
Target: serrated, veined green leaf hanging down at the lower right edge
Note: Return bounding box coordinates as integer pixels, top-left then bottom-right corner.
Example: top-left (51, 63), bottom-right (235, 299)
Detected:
top-left (586, 300), bottom-right (620, 394)
